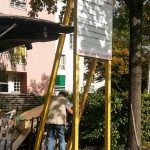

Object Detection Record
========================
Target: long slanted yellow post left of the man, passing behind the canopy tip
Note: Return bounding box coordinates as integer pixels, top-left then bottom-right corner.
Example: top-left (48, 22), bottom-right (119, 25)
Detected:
top-left (34, 0), bottom-right (73, 150)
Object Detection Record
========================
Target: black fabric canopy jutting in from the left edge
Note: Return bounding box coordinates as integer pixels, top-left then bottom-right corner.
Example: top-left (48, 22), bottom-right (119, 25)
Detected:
top-left (0, 14), bottom-right (74, 52)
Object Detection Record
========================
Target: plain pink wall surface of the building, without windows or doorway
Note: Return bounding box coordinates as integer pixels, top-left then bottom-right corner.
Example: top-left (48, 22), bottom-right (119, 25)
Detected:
top-left (0, 0), bottom-right (56, 94)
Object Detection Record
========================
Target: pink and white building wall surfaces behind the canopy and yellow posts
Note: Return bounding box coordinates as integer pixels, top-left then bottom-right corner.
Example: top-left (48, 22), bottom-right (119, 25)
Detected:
top-left (0, 0), bottom-right (84, 95)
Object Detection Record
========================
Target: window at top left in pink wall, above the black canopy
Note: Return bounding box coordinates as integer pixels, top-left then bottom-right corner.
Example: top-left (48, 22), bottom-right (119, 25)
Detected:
top-left (10, 0), bottom-right (27, 10)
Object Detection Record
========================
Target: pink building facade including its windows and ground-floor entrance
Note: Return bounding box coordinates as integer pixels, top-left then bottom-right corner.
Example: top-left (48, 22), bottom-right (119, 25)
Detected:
top-left (0, 0), bottom-right (56, 95)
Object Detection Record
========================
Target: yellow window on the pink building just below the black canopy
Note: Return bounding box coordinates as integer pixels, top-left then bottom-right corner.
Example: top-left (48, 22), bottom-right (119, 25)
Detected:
top-left (14, 46), bottom-right (27, 64)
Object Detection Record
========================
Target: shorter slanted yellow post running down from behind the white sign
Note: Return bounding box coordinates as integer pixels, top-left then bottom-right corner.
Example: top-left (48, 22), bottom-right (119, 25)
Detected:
top-left (67, 59), bottom-right (97, 150)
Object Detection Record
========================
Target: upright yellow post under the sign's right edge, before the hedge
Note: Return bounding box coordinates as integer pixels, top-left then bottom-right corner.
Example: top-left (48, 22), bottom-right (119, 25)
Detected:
top-left (105, 60), bottom-right (111, 150)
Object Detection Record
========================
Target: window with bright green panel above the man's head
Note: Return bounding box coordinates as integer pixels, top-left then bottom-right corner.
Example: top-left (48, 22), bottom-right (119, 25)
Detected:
top-left (55, 75), bottom-right (66, 91)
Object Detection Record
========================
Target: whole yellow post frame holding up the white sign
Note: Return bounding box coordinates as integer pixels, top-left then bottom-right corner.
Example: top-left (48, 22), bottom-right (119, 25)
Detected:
top-left (34, 0), bottom-right (111, 150)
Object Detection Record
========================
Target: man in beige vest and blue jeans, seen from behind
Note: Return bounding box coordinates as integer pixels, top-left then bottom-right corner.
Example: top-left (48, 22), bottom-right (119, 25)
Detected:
top-left (47, 91), bottom-right (73, 150)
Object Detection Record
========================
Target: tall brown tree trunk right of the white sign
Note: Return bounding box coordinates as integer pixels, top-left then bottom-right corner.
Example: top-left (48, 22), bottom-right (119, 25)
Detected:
top-left (128, 0), bottom-right (143, 150)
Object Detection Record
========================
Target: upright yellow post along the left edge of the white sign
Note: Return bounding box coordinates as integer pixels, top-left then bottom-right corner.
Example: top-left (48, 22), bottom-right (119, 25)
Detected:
top-left (73, 0), bottom-right (79, 150)
